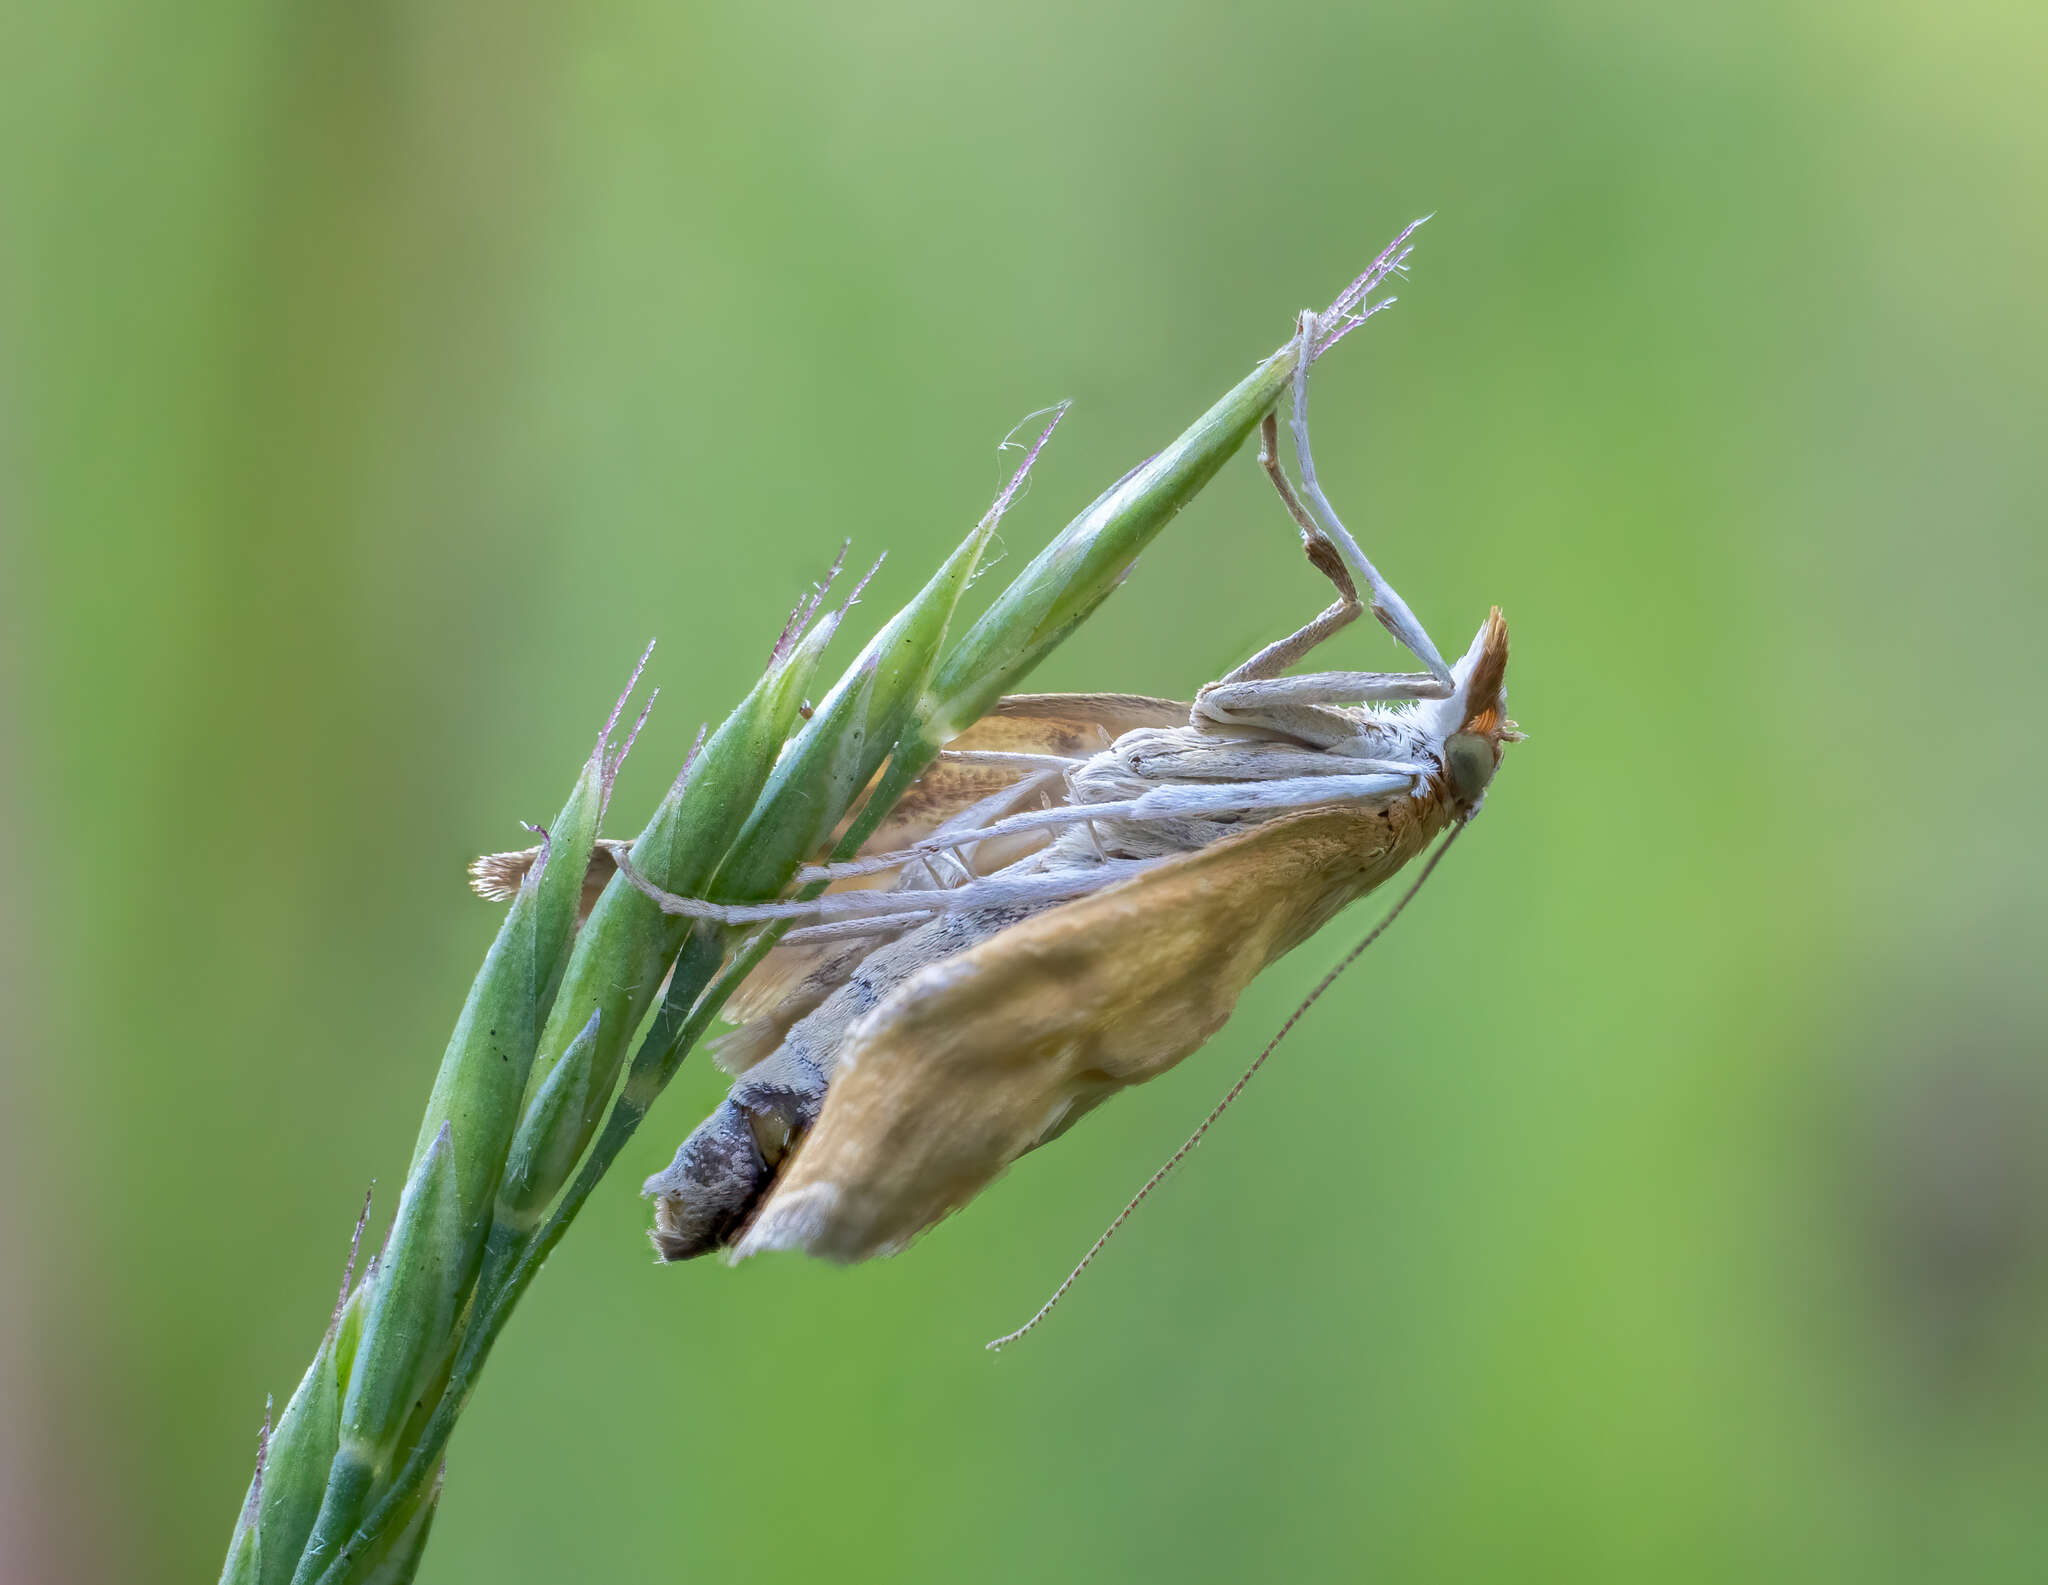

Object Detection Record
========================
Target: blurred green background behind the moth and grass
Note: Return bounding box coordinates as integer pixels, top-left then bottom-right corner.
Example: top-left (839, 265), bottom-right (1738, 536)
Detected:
top-left (0, 0), bottom-right (2048, 1583)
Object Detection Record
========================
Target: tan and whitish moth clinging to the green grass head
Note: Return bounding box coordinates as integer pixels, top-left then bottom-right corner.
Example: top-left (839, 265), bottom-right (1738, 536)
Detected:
top-left (479, 315), bottom-right (1520, 1326)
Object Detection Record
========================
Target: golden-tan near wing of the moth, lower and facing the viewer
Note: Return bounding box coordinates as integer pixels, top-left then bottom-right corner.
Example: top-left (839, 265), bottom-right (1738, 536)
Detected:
top-left (735, 799), bottom-right (1446, 1261)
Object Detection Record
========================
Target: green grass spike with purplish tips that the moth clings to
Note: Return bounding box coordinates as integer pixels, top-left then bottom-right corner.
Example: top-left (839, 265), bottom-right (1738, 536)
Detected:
top-left (221, 233), bottom-right (1405, 1585)
